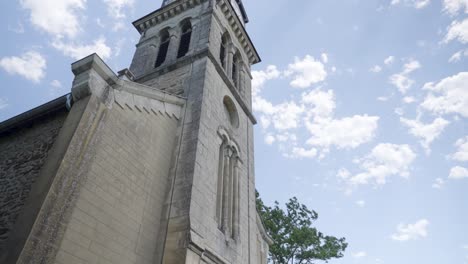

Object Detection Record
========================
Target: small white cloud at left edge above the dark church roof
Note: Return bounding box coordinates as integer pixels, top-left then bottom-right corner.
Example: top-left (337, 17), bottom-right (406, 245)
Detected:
top-left (0, 51), bottom-right (47, 83)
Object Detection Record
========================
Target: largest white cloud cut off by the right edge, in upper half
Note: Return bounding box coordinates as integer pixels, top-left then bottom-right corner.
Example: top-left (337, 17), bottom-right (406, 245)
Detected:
top-left (421, 72), bottom-right (468, 117)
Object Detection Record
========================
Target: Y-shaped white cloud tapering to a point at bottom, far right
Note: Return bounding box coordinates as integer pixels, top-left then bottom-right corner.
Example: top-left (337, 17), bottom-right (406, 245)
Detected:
top-left (400, 117), bottom-right (450, 154)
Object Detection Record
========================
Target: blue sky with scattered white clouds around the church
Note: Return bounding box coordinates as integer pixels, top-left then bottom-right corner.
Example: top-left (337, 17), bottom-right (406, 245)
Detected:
top-left (0, 0), bottom-right (468, 264)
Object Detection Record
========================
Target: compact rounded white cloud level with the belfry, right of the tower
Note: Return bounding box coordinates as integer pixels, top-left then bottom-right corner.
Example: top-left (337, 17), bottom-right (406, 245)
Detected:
top-left (285, 55), bottom-right (327, 88)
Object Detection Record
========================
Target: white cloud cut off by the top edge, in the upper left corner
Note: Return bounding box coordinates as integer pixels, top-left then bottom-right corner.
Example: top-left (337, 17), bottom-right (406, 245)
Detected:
top-left (20, 0), bottom-right (86, 37)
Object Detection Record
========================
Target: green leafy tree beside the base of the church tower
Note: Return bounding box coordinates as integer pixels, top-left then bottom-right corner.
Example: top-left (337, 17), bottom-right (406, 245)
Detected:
top-left (257, 192), bottom-right (348, 264)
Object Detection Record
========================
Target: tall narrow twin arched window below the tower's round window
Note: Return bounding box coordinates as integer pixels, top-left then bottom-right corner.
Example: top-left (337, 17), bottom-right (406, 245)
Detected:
top-left (216, 131), bottom-right (241, 240)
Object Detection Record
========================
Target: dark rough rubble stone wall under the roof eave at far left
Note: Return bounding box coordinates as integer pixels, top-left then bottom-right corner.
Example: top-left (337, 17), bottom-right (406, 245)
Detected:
top-left (0, 110), bottom-right (67, 252)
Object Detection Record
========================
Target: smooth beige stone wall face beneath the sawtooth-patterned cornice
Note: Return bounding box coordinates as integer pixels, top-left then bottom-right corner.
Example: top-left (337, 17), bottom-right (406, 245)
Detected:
top-left (55, 99), bottom-right (178, 264)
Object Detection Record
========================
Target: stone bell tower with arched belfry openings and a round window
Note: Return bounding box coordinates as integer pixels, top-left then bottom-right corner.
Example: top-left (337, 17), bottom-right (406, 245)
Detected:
top-left (130, 0), bottom-right (266, 263)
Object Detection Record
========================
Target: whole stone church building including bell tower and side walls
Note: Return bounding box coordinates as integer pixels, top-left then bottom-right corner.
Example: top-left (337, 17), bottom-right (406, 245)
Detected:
top-left (0, 0), bottom-right (272, 264)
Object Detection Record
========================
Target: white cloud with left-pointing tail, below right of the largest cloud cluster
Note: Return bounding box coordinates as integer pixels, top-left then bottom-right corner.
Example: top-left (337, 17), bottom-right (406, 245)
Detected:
top-left (346, 143), bottom-right (416, 187)
